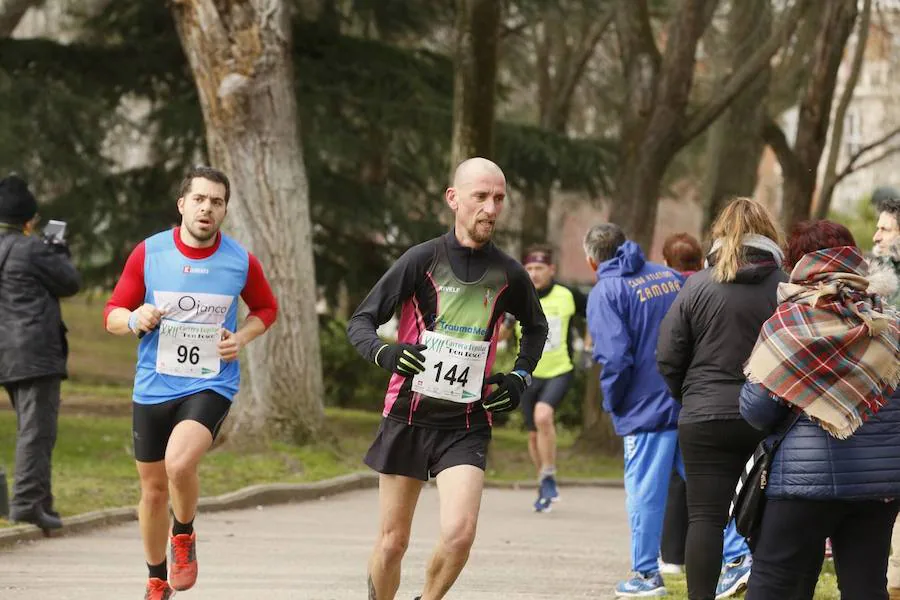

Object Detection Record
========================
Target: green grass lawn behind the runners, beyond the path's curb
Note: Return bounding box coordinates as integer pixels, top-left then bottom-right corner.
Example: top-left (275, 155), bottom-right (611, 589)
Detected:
top-left (0, 398), bottom-right (621, 523)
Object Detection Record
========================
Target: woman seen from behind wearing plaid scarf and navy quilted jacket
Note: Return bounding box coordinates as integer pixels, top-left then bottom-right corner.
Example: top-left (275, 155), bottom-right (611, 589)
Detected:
top-left (741, 221), bottom-right (900, 600)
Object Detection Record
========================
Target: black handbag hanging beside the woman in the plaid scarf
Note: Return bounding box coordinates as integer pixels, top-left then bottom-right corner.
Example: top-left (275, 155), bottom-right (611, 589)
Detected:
top-left (731, 413), bottom-right (802, 539)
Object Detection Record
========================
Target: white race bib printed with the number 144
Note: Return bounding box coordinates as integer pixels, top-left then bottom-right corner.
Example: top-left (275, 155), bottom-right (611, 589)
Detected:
top-left (412, 331), bottom-right (491, 404)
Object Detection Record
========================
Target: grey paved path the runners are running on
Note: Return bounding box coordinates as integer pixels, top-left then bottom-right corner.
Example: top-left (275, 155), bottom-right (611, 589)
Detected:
top-left (0, 488), bottom-right (630, 600)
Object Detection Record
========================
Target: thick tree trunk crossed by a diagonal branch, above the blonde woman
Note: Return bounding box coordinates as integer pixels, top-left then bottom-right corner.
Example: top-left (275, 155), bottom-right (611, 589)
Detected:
top-left (702, 0), bottom-right (772, 234)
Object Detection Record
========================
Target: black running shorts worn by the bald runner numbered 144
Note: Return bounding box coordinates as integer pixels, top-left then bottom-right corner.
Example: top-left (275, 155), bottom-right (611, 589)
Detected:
top-left (365, 419), bottom-right (491, 481)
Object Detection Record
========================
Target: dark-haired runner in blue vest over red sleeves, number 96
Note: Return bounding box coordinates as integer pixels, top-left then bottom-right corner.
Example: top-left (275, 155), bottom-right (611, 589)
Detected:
top-left (105, 167), bottom-right (278, 600)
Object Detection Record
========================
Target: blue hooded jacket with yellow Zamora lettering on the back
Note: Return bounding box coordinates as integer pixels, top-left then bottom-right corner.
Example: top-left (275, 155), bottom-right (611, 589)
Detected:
top-left (587, 241), bottom-right (682, 435)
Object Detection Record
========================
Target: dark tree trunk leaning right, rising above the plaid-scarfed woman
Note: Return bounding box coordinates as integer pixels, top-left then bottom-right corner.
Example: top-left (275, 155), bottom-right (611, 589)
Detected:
top-left (782, 0), bottom-right (857, 230)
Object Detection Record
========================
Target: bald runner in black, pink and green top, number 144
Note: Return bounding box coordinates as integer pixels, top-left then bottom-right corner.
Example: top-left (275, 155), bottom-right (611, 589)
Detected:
top-left (348, 158), bottom-right (547, 600)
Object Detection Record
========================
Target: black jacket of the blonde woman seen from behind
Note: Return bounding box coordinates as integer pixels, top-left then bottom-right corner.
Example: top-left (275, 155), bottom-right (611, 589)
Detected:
top-left (656, 255), bottom-right (788, 423)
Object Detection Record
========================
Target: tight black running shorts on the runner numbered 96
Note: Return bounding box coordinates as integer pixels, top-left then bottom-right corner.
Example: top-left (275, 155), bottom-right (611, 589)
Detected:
top-left (131, 390), bottom-right (231, 462)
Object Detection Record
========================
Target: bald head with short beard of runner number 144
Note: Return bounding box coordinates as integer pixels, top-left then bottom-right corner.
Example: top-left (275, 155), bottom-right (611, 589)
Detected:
top-left (446, 157), bottom-right (506, 248)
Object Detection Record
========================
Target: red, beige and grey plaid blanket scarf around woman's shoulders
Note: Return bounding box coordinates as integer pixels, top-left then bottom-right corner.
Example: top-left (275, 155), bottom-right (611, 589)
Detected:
top-left (745, 246), bottom-right (900, 439)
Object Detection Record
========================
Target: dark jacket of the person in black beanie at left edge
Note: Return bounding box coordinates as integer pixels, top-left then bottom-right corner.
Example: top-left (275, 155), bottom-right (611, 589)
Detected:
top-left (0, 228), bottom-right (81, 384)
